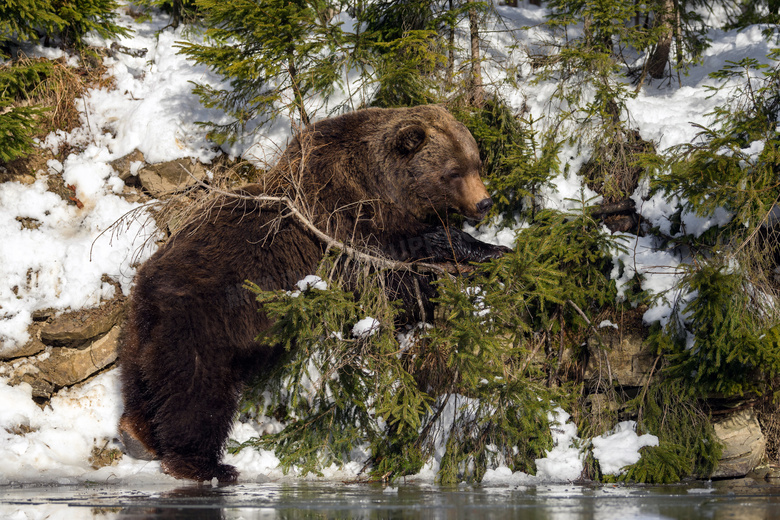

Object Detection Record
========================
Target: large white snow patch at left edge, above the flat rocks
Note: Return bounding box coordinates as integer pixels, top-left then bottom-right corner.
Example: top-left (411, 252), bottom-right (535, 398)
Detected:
top-left (0, 177), bottom-right (156, 352)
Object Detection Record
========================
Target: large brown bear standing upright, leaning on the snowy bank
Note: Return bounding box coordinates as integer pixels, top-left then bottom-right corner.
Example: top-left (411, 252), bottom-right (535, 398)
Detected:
top-left (114, 106), bottom-right (506, 482)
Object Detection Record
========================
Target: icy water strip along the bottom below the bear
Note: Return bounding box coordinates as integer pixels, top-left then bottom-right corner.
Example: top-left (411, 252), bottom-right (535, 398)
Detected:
top-left (0, 479), bottom-right (780, 520)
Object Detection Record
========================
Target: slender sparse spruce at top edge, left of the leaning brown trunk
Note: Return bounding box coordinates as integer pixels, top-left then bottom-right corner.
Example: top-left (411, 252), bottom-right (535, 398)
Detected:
top-left (536, 0), bottom-right (658, 209)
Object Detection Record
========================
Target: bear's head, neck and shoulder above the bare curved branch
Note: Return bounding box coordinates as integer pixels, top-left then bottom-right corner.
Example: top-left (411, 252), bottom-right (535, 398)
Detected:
top-left (274, 105), bottom-right (493, 234)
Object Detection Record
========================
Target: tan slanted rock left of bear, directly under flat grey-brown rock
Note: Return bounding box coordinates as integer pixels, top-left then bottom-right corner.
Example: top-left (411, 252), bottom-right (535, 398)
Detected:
top-left (38, 325), bottom-right (120, 387)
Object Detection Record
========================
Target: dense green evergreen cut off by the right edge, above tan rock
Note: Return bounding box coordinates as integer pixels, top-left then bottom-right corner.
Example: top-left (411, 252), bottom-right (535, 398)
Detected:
top-left (652, 46), bottom-right (780, 397)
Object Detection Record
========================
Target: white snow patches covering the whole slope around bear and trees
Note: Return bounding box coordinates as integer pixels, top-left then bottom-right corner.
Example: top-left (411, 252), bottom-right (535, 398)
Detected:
top-left (0, 3), bottom-right (769, 485)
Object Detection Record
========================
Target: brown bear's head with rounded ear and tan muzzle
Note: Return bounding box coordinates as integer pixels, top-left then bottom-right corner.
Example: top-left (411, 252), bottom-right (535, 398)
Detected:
top-left (384, 106), bottom-right (493, 220)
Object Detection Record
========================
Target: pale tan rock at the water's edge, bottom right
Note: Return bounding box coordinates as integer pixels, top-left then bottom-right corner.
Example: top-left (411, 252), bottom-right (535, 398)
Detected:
top-left (712, 409), bottom-right (766, 478)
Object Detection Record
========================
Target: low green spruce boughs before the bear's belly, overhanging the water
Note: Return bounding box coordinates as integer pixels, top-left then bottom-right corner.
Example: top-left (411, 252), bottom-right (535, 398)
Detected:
top-left (232, 239), bottom-right (567, 483)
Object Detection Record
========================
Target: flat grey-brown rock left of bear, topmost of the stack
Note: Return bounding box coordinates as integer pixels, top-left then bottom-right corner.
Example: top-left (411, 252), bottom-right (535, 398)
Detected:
top-left (41, 298), bottom-right (125, 344)
